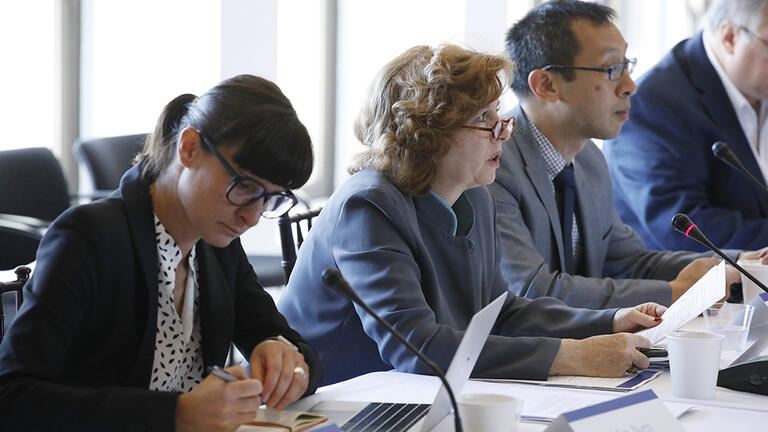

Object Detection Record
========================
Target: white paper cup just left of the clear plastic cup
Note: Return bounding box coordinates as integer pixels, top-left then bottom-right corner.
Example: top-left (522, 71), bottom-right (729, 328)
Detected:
top-left (667, 332), bottom-right (725, 399)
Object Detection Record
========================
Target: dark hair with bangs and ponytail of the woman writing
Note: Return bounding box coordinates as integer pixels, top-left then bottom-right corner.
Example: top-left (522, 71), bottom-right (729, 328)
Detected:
top-left (135, 75), bottom-right (314, 189)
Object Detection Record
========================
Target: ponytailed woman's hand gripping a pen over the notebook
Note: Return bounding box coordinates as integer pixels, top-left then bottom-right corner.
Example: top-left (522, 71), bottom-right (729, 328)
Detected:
top-left (175, 366), bottom-right (262, 432)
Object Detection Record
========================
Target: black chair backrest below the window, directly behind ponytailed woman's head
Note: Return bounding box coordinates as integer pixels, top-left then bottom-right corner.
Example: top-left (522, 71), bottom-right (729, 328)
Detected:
top-left (74, 134), bottom-right (147, 191)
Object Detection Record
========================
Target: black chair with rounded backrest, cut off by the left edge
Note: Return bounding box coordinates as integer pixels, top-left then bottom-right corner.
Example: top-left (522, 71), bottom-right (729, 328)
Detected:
top-left (0, 147), bottom-right (69, 270)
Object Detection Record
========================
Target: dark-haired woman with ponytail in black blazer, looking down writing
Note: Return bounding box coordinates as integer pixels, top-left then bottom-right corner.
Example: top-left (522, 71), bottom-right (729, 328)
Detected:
top-left (0, 75), bottom-right (321, 431)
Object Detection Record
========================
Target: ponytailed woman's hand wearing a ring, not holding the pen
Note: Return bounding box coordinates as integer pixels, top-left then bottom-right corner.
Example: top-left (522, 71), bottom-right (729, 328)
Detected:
top-left (251, 340), bottom-right (309, 410)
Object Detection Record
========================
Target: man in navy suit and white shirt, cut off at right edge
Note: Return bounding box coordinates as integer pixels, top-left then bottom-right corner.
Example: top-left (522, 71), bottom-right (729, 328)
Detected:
top-left (603, 0), bottom-right (768, 250)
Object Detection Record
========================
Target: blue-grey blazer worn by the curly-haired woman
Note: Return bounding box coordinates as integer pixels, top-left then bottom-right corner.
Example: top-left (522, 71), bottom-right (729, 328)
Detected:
top-left (278, 169), bottom-right (615, 384)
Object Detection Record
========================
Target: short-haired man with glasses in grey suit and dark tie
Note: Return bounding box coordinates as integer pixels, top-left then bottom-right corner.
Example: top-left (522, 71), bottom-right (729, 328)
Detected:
top-left (490, 1), bottom-right (736, 309)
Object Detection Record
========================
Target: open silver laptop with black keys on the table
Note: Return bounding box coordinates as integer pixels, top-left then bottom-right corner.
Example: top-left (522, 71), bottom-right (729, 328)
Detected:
top-left (310, 292), bottom-right (507, 432)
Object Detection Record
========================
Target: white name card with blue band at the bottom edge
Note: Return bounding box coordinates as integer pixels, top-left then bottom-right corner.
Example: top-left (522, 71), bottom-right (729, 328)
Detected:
top-left (546, 390), bottom-right (684, 432)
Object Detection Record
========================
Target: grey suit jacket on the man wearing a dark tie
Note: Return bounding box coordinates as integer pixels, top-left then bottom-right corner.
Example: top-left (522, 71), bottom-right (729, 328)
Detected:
top-left (489, 105), bottom-right (704, 309)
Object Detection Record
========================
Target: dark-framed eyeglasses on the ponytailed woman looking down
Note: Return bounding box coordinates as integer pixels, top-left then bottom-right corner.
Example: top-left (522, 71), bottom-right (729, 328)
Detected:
top-left (197, 131), bottom-right (298, 219)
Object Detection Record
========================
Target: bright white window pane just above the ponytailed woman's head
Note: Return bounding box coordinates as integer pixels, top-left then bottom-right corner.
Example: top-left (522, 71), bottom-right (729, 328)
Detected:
top-left (80, 0), bottom-right (221, 138)
